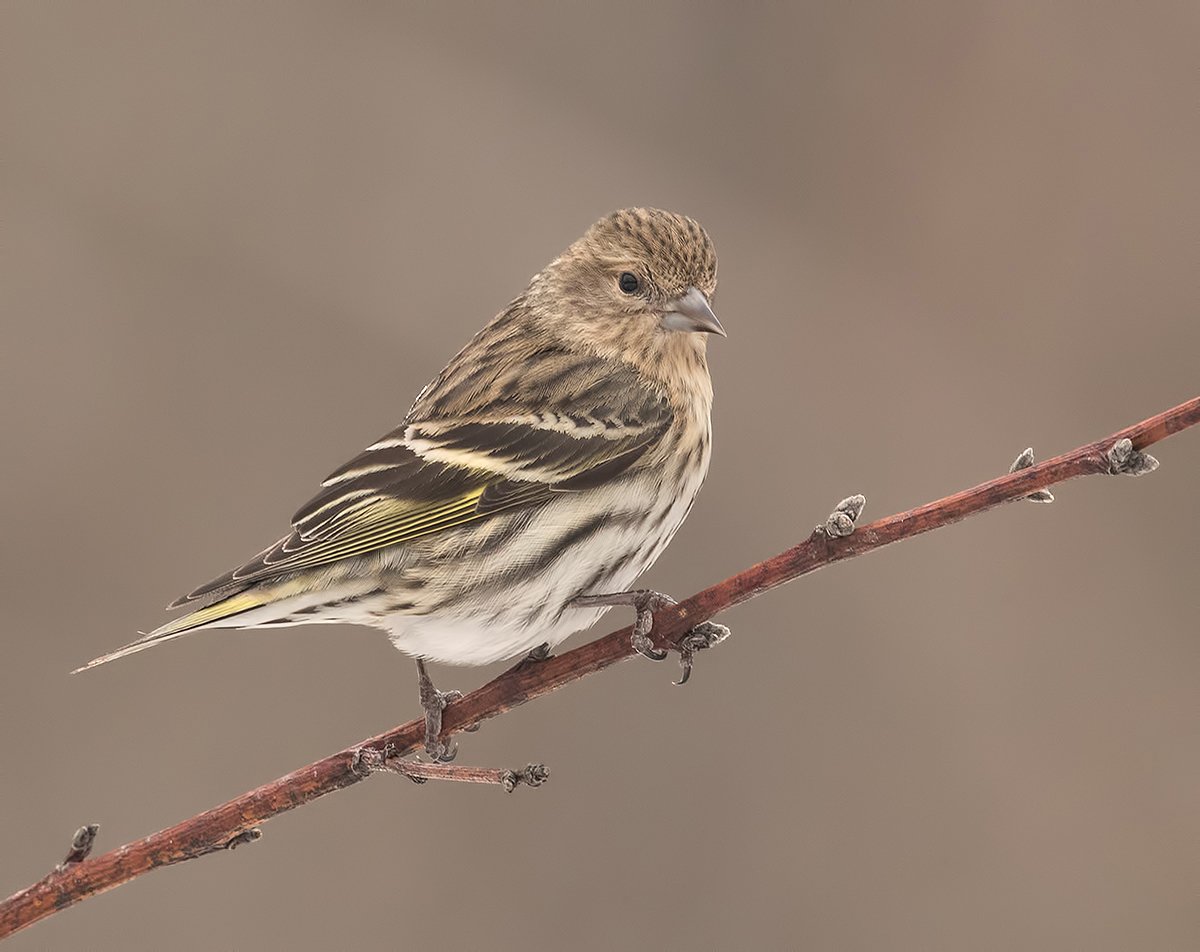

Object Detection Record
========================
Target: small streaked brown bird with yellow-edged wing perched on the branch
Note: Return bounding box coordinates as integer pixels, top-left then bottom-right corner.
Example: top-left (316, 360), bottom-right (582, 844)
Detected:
top-left (77, 208), bottom-right (727, 761)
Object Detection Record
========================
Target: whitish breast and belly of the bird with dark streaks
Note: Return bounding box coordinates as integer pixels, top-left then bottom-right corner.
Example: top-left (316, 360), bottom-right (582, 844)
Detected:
top-left (384, 419), bottom-right (710, 664)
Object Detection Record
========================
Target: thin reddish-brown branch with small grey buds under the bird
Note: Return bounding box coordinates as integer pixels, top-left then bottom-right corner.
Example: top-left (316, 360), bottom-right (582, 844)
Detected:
top-left (0, 397), bottom-right (1200, 939)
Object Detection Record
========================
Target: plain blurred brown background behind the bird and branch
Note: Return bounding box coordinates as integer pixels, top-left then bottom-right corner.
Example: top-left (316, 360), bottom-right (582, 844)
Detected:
top-left (0, 0), bottom-right (1200, 951)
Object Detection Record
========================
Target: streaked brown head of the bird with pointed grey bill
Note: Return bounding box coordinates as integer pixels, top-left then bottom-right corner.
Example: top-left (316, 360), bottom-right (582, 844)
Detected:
top-left (530, 208), bottom-right (725, 355)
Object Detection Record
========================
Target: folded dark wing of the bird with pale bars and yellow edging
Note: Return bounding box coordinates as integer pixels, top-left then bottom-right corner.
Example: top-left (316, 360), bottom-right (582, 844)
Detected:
top-left (172, 366), bottom-right (671, 607)
